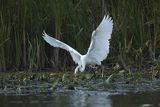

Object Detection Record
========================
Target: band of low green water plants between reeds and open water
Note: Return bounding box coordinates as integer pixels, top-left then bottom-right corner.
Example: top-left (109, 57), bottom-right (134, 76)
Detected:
top-left (0, 71), bottom-right (160, 94)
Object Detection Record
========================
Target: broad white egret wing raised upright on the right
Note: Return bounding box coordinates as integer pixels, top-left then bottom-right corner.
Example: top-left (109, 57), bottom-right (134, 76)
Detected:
top-left (87, 16), bottom-right (113, 62)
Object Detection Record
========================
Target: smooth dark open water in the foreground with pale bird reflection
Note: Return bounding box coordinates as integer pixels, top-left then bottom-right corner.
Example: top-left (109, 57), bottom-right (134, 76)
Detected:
top-left (0, 91), bottom-right (160, 107)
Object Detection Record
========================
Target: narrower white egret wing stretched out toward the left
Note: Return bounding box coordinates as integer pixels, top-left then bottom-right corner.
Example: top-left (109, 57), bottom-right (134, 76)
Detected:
top-left (42, 31), bottom-right (81, 63)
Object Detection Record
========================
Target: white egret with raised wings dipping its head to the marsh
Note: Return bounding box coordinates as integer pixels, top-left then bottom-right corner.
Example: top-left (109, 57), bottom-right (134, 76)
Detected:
top-left (43, 16), bottom-right (113, 74)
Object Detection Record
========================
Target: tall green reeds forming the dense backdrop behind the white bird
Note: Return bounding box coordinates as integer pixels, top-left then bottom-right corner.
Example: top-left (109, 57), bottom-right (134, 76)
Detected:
top-left (0, 0), bottom-right (160, 76)
